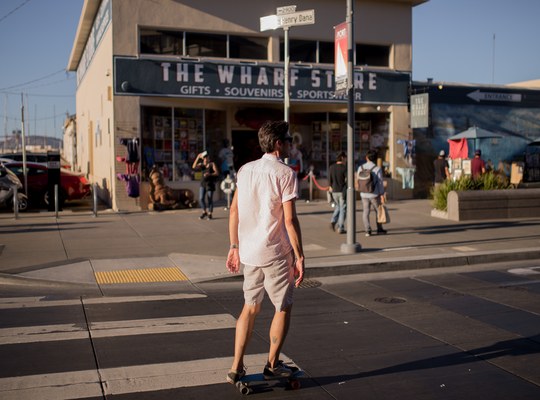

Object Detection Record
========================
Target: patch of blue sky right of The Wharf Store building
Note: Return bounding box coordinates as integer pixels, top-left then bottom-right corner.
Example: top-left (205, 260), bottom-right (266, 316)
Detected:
top-left (413, 0), bottom-right (540, 84)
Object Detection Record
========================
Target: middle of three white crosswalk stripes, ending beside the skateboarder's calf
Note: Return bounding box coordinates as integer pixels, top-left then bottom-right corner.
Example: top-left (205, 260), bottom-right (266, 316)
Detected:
top-left (0, 314), bottom-right (236, 345)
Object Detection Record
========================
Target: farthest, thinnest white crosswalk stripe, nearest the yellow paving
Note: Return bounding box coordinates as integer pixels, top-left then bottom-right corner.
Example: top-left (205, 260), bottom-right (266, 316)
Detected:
top-left (0, 293), bottom-right (207, 310)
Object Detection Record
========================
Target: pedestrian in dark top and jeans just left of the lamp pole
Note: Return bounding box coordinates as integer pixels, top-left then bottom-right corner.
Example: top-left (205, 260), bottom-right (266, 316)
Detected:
top-left (328, 152), bottom-right (347, 233)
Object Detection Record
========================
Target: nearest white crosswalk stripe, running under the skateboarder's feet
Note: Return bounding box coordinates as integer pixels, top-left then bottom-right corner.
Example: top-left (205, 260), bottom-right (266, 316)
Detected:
top-left (0, 353), bottom-right (292, 400)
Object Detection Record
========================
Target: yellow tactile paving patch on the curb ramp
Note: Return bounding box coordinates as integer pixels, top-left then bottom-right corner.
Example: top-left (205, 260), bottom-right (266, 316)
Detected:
top-left (94, 267), bottom-right (188, 285)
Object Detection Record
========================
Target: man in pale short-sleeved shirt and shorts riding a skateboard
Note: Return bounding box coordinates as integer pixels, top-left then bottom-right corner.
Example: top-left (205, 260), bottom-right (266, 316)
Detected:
top-left (226, 121), bottom-right (304, 384)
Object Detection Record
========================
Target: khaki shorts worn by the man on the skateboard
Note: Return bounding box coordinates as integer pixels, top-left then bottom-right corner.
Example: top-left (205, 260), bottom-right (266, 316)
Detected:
top-left (244, 252), bottom-right (294, 311)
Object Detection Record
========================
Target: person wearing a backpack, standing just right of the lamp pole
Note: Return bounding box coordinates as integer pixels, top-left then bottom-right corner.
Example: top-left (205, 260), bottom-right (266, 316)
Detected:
top-left (356, 150), bottom-right (386, 236)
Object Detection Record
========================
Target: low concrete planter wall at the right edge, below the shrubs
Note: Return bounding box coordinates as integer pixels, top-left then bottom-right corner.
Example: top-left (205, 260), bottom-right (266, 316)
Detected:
top-left (447, 189), bottom-right (540, 221)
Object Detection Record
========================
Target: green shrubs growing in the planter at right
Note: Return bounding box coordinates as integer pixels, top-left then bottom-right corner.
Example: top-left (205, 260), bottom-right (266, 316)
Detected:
top-left (431, 172), bottom-right (510, 211)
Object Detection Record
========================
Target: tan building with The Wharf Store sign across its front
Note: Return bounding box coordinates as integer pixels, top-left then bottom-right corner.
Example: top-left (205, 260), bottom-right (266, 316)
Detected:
top-left (68, 0), bottom-right (425, 210)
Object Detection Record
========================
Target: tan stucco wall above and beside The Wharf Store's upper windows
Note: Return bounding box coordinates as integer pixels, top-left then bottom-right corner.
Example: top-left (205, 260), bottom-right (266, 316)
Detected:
top-left (109, 0), bottom-right (412, 71)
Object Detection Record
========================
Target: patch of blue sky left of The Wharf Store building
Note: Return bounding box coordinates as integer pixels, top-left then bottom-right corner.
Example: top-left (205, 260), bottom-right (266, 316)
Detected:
top-left (0, 0), bottom-right (83, 143)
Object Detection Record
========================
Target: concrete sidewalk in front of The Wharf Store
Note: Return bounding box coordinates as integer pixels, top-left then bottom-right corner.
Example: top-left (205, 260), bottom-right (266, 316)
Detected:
top-left (0, 200), bottom-right (540, 285)
